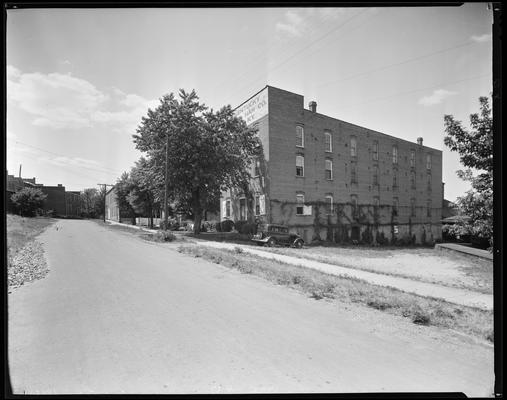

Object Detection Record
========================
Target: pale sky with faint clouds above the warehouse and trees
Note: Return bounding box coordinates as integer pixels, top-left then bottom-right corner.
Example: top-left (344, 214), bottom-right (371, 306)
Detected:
top-left (6, 3), bottom-right (493, 201)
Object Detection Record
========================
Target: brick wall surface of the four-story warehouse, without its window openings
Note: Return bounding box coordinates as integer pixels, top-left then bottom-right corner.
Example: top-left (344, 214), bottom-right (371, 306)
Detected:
top-left (222, 87), bottom-right (443, 242)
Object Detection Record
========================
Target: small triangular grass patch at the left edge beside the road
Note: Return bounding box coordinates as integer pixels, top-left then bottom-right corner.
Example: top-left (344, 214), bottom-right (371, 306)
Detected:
top-left (7, 214), bottom-right (56, 257)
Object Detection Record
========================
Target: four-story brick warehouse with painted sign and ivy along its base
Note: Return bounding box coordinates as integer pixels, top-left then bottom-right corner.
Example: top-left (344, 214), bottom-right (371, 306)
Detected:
top-left (221, 86), bottom-right (443, 243)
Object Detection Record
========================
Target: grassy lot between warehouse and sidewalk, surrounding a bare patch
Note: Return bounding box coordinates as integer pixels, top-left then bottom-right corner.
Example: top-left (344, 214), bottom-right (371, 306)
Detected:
top-left (254, 246), bottom-right (493, 294)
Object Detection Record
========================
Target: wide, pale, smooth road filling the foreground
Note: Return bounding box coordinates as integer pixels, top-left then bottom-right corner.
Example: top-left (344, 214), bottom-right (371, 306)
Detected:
top-left (9, 220), bottom-right (494, 396)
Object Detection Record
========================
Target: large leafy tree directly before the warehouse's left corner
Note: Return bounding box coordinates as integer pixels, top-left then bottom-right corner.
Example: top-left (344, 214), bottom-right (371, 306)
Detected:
top-left (133, 90), bottom-right (260, 234)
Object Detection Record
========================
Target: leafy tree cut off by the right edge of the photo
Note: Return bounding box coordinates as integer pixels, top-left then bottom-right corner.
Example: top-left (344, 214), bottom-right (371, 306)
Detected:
top-left (444, 97), bottom-right (493, 248)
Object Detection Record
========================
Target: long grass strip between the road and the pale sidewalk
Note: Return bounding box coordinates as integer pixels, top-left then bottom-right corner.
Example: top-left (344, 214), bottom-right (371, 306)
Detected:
top-left (178, 245), bottom-right (493, 342)
